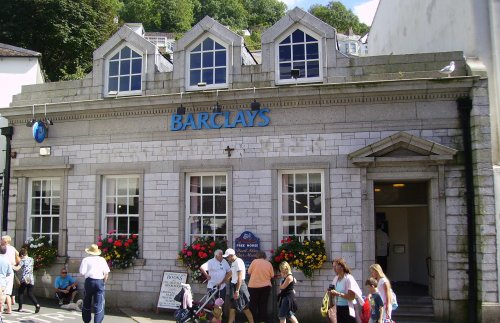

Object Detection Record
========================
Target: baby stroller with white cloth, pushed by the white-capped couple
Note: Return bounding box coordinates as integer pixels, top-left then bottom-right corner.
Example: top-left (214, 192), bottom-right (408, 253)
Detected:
top-left (174, 284), bottom-right (224, 323)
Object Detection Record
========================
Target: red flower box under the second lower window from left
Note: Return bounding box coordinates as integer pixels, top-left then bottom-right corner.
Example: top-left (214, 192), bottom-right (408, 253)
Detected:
top-left (96, 232), bottom-right (139, 269)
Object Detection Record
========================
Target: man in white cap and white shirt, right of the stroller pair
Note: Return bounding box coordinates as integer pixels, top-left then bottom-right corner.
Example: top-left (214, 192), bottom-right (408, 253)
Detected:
top-left (223, 248), bottom-right (254, 323)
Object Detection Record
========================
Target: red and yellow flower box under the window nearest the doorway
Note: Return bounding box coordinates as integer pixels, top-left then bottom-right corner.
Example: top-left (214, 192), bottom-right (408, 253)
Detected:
top-left (271, 236), bottom-right (326, 278)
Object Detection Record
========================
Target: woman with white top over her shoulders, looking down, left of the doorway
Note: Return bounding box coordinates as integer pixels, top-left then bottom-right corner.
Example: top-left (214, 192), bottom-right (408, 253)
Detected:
top-left (328, 258), bottom-right (363, 323)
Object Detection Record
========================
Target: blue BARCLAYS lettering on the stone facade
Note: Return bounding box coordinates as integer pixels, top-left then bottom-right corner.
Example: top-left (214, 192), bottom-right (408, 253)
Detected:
top-left (170, 109), bottom-right (271, 131)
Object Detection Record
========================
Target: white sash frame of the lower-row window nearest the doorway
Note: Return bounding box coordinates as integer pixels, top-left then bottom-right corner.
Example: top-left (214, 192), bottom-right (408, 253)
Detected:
top-left (278, 169), bottom-right (326, 241)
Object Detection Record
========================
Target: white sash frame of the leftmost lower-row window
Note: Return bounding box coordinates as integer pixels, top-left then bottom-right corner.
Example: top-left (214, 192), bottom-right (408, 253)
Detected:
top-left (26, 177), bottom-right (62, 247)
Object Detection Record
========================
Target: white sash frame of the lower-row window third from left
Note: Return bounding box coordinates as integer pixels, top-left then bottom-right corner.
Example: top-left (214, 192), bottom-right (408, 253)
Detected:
top-left (184, 172), bottom-right (229, 243)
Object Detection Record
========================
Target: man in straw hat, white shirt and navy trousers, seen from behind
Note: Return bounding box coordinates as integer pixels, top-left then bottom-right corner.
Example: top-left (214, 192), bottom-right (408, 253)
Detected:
top-left (80, 244), bottom-right (109, 323)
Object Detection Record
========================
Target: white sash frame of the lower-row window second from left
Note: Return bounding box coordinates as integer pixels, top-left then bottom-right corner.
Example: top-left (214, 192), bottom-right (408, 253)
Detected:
top-left (101, 174), bottom-right (143, 237)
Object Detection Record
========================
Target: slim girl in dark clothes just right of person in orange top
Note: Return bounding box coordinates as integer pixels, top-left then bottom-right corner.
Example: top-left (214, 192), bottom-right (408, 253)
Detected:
top-left (278, 261), bottom-right (299, 323)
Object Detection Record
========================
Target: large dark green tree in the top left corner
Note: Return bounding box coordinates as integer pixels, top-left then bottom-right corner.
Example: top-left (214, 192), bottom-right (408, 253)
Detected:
top-left (0, 0), bottom-right (120, 81)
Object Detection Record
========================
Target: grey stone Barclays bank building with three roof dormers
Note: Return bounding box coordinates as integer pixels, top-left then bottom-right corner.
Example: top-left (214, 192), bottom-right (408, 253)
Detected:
top-left (2, 8), bottom-right (499, 322)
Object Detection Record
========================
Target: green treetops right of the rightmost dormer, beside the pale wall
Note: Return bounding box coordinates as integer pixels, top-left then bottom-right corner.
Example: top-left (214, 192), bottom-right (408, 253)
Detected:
top-left (309, 1), bottom-right (370, 35)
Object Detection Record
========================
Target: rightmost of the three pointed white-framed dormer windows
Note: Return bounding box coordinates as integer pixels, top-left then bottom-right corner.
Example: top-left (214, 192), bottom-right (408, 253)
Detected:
top-left (276, 29), bottom-right (322, 84)
